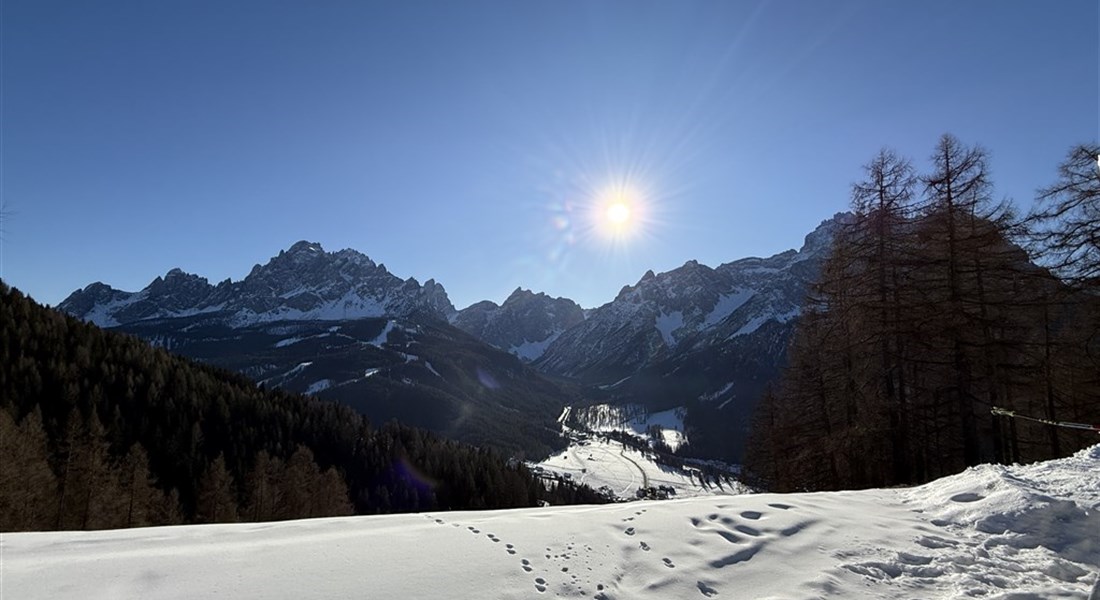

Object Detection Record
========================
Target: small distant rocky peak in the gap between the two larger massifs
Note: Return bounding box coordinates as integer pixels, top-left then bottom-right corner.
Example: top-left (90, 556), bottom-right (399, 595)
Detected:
top-left (451, 287), bottom-right (584, 361)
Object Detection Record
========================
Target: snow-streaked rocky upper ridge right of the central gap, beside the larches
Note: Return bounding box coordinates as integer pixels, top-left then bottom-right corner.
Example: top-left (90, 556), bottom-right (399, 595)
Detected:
top-left (537, 214), bottom-right (846, 383)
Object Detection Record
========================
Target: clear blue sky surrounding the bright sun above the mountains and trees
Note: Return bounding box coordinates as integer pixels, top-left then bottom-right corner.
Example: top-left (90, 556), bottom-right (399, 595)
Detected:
top-left (0, 0), bottom-right (1100, 307)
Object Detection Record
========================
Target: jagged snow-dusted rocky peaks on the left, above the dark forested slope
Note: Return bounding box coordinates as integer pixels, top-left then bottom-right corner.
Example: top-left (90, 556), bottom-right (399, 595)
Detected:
top-left (58, 241), bottom-right (454, 327)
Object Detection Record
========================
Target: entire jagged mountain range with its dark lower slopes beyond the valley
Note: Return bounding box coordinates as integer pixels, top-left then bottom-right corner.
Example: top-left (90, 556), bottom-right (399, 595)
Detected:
top-left (58, 214), bottom-right (847, 458)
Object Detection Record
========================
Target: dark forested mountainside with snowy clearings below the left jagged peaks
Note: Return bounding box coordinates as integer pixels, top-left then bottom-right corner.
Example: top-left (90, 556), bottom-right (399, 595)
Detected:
top-left (118, 315), bottom-right (574, 456)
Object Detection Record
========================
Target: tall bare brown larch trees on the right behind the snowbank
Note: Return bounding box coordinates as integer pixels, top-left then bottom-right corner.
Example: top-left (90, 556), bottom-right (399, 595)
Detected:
top-left (746, 135), bottom-right (1100, 491)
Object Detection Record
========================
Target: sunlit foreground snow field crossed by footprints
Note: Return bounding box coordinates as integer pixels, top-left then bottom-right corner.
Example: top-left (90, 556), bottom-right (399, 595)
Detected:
top-left (0, 446), bottom-right (1100, 600)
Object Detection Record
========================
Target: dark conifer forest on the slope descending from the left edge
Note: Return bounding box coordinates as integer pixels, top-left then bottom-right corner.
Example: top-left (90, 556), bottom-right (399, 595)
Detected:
top-left (0, 282), bottom-right (604, 531)
